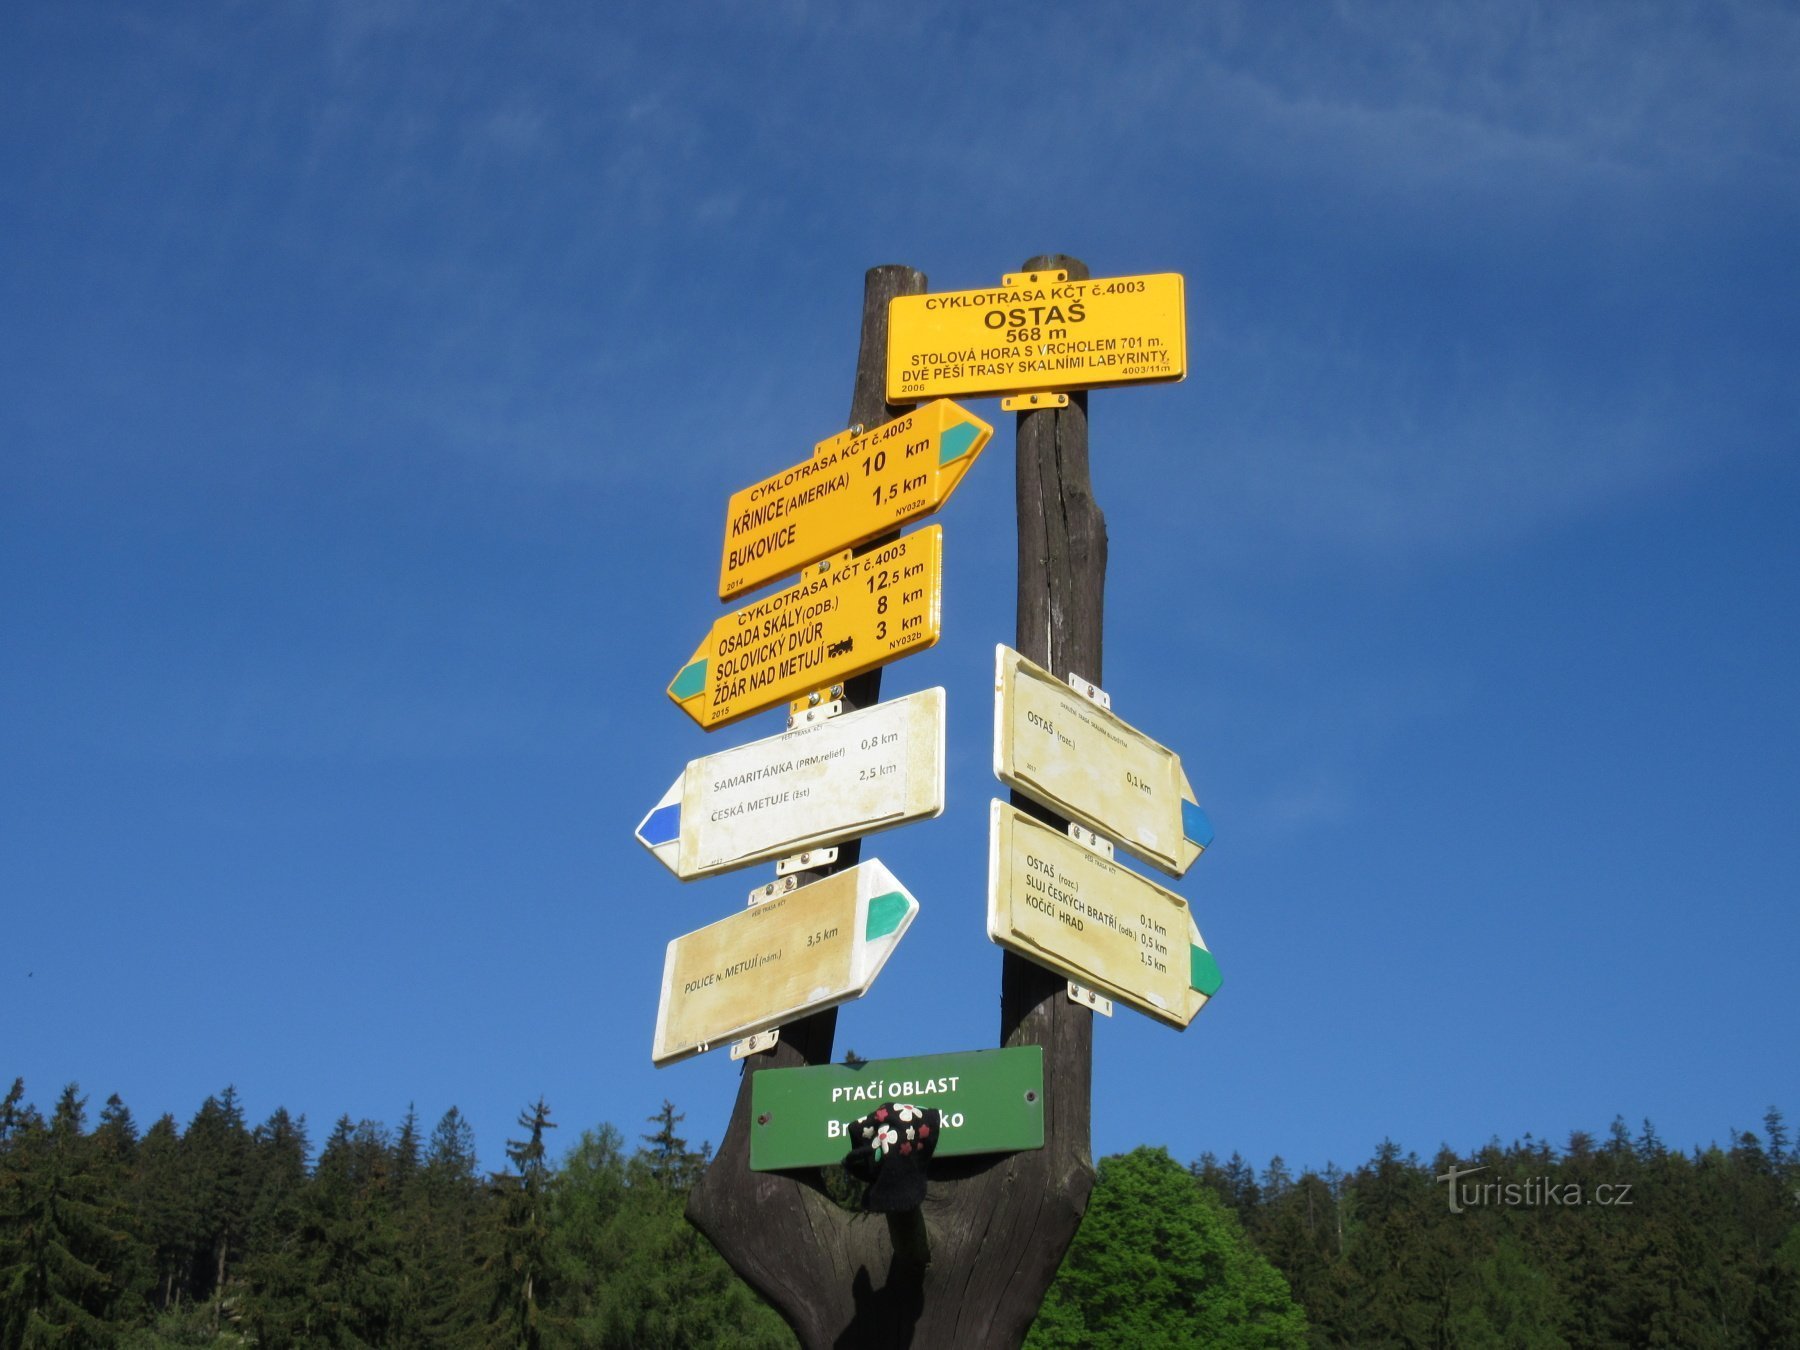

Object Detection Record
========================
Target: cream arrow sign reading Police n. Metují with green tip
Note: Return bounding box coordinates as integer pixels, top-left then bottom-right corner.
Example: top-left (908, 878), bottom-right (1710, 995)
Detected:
top-left (650, 860), bottom-right (918, 1067)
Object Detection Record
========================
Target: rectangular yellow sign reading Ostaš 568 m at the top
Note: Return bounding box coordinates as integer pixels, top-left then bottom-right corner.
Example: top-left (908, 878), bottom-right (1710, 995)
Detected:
top-left (887, 272), bottom-right (1188, 403)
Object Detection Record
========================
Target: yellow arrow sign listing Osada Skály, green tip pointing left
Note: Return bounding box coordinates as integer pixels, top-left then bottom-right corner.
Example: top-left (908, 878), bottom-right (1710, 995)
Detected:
top-left (670, 526), bottom-right (943, 731)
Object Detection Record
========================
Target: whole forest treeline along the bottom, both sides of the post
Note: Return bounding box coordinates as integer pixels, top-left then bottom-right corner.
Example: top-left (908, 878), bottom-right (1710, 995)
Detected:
top-left (0, 1082), bottom-right (1800, 1350)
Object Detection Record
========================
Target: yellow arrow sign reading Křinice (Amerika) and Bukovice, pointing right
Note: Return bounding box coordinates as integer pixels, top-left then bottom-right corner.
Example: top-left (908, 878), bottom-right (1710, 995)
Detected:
top-left (718, 400), bottom-right (994, 599)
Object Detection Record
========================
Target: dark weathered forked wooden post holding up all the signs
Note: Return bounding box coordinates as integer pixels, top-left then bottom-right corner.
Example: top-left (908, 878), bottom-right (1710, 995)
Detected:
top-left (688, 257), bottom-right (1107, 1346)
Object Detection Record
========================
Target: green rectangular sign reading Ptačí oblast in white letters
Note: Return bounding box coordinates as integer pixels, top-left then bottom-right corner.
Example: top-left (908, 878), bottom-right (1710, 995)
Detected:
top-left (751, 1046), bottom-right (1044, 1172)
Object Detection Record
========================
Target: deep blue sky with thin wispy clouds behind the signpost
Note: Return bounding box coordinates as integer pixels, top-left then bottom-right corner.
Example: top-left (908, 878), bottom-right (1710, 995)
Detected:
top-left (0, 0), bottom-right (1800, 1166)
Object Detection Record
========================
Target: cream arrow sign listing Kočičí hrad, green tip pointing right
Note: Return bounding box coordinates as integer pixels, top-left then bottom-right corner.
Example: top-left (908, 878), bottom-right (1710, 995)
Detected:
top-left (988, 801), bottom-right (1220, 1028)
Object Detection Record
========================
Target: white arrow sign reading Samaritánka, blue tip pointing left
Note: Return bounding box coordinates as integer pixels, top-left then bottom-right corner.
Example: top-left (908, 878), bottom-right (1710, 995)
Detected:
top-left (637, 689), bottom-right (943, 880)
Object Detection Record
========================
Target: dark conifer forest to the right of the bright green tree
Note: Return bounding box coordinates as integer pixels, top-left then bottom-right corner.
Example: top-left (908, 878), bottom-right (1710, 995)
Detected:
top-left (1190, 1107), bottom-right (1800, 1350)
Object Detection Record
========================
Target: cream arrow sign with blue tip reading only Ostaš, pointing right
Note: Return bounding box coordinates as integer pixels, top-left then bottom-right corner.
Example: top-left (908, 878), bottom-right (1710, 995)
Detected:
top-left (994, 646), bottom-right (1213, 877)
